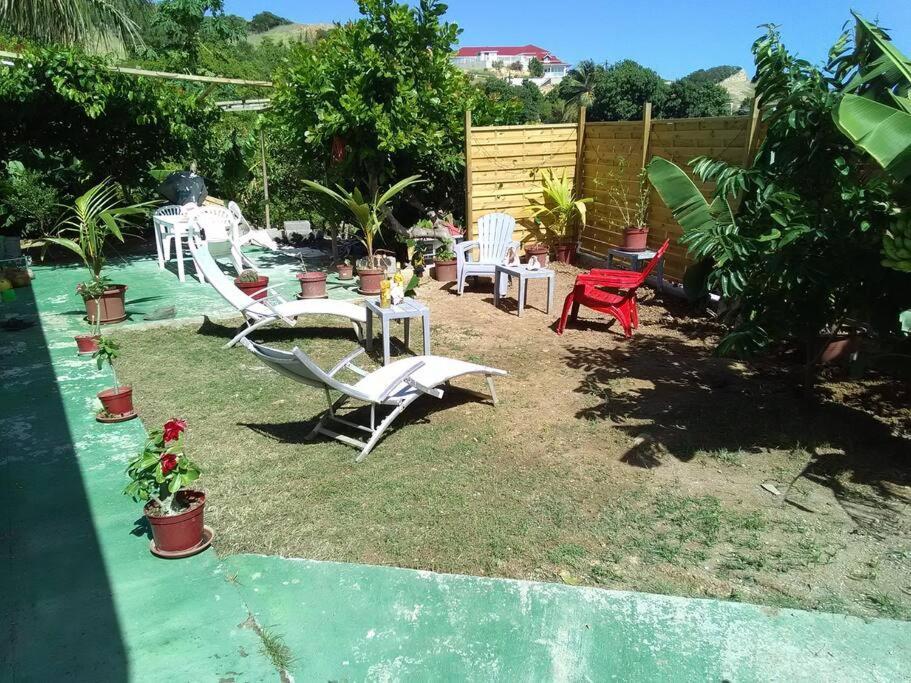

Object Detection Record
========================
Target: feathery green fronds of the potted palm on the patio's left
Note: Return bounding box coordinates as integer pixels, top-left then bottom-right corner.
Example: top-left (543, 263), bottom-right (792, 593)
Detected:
top-left (43, 178), bottom-right (155, 280)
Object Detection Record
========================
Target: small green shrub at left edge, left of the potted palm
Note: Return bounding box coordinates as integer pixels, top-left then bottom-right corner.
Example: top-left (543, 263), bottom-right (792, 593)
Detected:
top-left (0, 161), bottom-right (60, 237)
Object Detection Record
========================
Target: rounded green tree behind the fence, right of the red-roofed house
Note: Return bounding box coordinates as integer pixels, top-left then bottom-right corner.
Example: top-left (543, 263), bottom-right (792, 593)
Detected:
top-left (590, 59), bottom-right (668, 121)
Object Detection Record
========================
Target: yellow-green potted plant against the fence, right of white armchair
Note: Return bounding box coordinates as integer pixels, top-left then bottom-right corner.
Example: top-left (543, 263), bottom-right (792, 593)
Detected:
top-left (525, 169), bottom-right (592, 265)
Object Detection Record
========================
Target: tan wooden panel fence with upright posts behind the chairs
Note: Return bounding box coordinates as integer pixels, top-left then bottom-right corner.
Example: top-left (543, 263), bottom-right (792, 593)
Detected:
top-left (465, 105), bottom-right (759, 279)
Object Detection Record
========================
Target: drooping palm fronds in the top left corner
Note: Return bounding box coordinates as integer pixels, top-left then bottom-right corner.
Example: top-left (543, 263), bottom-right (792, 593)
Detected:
top-left (0, 0), bottom-right (151, 47)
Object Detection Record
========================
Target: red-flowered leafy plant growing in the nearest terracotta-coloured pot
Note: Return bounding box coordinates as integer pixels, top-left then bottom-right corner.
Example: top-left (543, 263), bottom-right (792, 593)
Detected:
top-left (123, 418), bottom-right (199, 515)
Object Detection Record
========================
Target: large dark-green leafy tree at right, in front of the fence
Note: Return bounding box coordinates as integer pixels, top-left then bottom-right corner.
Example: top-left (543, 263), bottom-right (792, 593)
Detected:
top-left (649, 21), bottom-right (907, 366)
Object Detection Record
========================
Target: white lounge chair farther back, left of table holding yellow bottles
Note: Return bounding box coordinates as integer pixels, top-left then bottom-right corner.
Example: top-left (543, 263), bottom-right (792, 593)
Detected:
top-left (190, 240), bottom-right (367, 349)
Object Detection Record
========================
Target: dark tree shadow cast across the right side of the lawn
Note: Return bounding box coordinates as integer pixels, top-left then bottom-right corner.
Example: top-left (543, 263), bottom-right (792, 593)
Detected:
top-left (566, 336), bottom-right (911, 537)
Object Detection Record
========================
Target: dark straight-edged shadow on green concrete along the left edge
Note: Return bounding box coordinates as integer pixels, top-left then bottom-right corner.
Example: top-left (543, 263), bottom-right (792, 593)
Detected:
top-left (0, 289), bottom-right (129, 681)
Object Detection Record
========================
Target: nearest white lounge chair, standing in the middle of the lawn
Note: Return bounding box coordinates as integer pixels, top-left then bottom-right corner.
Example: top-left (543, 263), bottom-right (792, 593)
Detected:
top-left (242, 338), bottom-right (506, 462)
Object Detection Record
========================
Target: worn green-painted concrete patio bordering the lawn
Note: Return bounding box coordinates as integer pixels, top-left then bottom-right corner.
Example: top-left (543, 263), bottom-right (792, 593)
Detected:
top-left (0, 259), bottom-right (911, 681)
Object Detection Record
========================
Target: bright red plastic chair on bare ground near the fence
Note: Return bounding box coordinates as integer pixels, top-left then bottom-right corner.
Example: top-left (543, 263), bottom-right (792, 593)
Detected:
top-left (557, 240), bottom-right (671, 337)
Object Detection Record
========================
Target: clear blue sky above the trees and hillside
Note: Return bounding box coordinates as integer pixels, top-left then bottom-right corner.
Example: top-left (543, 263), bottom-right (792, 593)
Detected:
top-left (225, 0), bottom-right (911, 78)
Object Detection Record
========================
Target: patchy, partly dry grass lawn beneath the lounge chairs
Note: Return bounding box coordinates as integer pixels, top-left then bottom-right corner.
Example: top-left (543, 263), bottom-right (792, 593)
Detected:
top-left (116, 268), bottom-right (911, 619)
